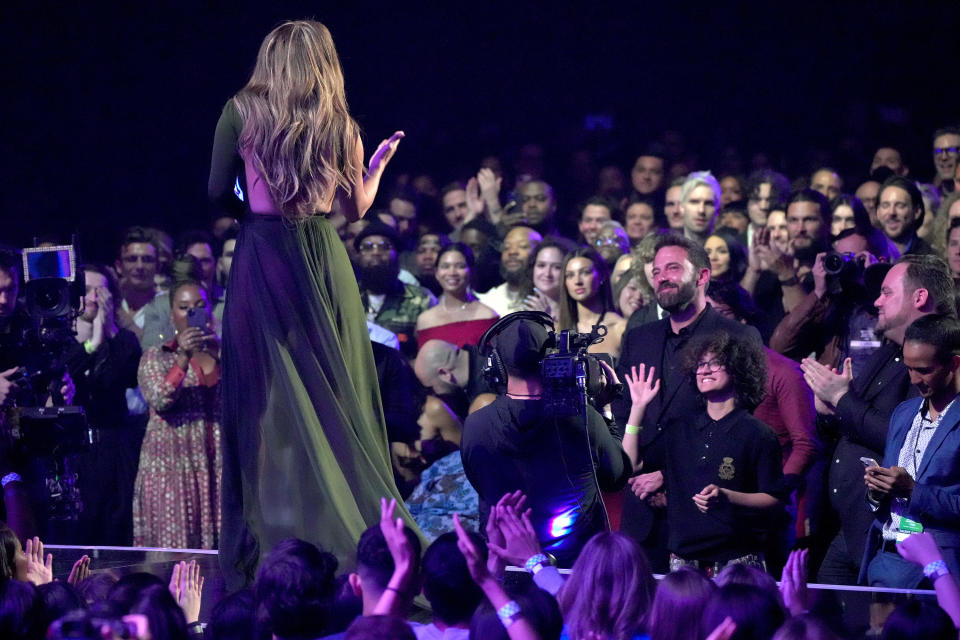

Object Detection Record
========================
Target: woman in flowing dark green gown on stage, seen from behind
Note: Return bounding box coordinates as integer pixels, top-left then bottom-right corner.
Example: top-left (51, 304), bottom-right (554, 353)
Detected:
top-left (209, 21), bottom-right (406, 589)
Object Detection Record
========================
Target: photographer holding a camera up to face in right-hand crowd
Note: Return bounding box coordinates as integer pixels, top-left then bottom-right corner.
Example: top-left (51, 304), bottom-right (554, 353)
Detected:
top-left (770, 228), bottom-right (889, 370)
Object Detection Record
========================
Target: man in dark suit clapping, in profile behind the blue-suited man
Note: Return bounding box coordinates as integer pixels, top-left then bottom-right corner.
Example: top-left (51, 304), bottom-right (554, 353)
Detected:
top-left (801, 255), bottom-right (955, 584)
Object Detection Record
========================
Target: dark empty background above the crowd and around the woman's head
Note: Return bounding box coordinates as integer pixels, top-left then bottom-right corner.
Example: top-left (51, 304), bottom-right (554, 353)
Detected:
top-left (0, 0), bottom-right (960, 260)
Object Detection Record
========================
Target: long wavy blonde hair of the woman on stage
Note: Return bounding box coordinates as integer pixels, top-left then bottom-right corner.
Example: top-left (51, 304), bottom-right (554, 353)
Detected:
top-left (234, 20), bottom-right (362, 219)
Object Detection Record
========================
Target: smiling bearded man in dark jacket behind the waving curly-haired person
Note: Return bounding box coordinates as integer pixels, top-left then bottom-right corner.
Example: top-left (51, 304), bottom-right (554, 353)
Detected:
top-left (613, 235), bottom-right (760, 572)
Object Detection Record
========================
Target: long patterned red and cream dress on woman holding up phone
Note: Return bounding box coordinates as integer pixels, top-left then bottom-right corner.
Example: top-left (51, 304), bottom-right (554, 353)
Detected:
top-left (133, 342), bottom-right (222, 549)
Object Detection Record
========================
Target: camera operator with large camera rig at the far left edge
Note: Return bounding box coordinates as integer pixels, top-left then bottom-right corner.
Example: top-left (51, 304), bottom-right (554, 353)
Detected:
top-left (0, 247), bottom-right (86, 541)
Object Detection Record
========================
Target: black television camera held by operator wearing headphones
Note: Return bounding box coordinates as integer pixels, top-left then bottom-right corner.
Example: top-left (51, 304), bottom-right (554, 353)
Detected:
top-left (540, 324), bottom-right (607, 417)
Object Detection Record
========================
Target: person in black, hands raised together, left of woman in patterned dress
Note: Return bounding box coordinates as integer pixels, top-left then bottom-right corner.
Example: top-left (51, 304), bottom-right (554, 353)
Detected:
top-left (66, 265), bottom-right (146, 545)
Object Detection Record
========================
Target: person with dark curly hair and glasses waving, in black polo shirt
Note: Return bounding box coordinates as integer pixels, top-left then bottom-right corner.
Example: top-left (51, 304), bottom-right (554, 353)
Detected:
top-left (623, 331), bottom-right (788, 577)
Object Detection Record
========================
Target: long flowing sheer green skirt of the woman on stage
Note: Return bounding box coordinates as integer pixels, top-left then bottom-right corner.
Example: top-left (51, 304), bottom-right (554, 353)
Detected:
top-left (220, 216), bottom-right (412, 590)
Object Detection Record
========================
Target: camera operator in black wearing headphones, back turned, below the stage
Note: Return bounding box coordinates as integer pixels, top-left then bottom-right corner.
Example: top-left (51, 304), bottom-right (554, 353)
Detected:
top-left (460, 312), bottom-right (630, 566)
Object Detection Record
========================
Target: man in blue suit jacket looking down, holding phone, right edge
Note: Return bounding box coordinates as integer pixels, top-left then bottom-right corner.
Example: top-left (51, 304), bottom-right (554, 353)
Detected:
top-left (860, 315), bottom-right (960, 589)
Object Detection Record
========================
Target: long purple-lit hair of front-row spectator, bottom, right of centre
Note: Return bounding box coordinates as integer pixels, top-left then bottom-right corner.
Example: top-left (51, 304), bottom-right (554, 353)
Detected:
top-left (557, 531), bottom-right (656, 640)
